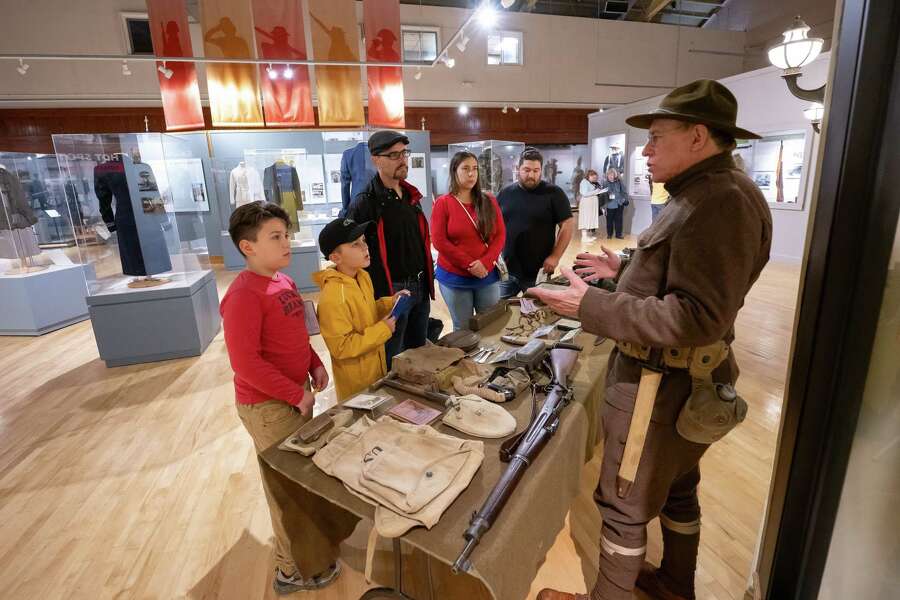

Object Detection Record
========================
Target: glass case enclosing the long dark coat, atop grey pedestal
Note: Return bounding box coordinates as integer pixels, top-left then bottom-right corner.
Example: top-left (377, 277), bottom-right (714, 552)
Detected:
top-left (53, 133), bottom-right (209, 296)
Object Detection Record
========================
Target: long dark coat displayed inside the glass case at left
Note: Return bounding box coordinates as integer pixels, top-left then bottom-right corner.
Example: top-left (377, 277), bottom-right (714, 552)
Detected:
top-left (94, 156), bottom-right (172, 277)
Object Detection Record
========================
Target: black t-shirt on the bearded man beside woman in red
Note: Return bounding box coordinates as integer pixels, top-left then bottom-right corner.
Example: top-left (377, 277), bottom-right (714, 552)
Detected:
top-left (497, 181), bottom-right (572, 279)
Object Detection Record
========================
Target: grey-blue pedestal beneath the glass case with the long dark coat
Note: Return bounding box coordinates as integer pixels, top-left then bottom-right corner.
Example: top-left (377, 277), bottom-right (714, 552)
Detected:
top-left (87, 271), bottom-right (220, 367)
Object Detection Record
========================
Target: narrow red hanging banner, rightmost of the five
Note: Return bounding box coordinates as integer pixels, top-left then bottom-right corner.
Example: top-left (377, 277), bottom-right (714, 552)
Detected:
top-left (363, 0), bottom-right (406, 129)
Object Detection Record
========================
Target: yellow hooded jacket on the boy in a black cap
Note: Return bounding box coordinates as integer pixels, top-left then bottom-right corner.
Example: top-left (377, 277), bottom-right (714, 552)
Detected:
top-left (312, 268), bottom-right (393, 401)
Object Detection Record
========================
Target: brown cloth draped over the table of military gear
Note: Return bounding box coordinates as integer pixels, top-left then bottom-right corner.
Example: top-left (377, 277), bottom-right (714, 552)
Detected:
top-left (260, 310), bottom-right (613, 600)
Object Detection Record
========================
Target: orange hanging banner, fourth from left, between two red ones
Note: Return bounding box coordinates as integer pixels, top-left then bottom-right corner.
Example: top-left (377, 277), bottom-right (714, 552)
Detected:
top-left (309, 0), bottom-right (365, 127)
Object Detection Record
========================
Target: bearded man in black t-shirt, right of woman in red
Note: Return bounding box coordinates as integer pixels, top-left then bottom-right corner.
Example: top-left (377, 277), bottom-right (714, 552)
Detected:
top-left (497, 148), bottom-right (575, 298)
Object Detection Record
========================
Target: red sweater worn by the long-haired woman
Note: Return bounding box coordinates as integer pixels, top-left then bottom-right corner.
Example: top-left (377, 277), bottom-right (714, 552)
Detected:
top-left (431, 194), bottom-right (506, 277)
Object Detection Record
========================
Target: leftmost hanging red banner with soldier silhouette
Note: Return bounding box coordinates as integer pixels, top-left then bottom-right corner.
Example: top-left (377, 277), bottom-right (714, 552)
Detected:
top-left (147, 0), bottom-right (205, 131)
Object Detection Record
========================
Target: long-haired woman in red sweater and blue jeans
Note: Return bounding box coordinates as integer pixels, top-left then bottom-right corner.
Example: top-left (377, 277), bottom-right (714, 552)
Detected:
top-left (431, 152), bottom-right (506, 331)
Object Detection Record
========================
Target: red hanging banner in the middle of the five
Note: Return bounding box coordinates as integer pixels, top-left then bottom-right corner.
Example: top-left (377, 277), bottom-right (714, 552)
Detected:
top-left (253, 0), bottom-right (316, 126)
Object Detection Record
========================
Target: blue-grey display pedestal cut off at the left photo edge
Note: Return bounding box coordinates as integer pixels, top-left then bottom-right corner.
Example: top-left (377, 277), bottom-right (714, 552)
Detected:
top-left (0, 265), bottom-right (88, 335)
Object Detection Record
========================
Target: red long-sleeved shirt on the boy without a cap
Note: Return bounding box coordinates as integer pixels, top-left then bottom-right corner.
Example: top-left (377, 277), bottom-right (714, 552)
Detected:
top-left (219, 271), bottom-right (322, 406)
